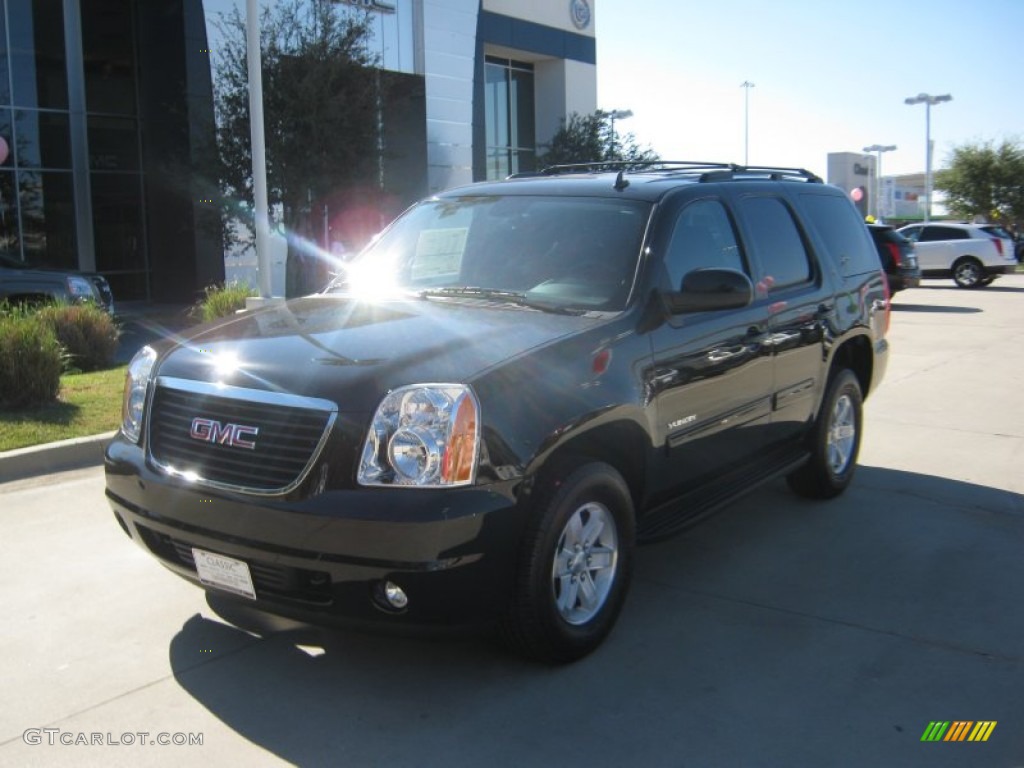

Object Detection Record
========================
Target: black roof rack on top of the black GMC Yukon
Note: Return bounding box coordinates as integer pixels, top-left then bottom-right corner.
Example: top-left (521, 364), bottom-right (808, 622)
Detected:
top-left (509, 160), bottom-right (823, 186)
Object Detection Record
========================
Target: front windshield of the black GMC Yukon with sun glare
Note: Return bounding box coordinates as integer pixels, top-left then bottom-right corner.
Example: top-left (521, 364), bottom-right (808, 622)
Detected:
top-left (329, 196), bottom-right (650, 310)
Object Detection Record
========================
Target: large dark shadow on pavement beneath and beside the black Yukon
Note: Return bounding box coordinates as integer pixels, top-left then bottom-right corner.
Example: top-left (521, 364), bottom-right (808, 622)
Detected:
top-left (169, 466), bottom-right (1024, 766)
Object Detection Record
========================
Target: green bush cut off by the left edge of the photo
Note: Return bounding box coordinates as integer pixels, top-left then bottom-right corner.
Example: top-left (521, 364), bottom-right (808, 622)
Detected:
top-left (0, 309), bottom-right (63, 409)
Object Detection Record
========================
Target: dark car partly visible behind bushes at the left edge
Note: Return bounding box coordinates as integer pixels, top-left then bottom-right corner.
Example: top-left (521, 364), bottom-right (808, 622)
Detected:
top-left (0, 253), bottom-right (114, 314)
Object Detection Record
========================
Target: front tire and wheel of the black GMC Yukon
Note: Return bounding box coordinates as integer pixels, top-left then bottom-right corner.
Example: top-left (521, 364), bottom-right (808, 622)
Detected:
top-left (502, 462), bottom-right (635, 664)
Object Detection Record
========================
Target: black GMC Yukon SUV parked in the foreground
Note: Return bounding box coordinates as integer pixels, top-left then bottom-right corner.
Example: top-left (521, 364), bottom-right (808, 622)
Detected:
top-left (105, 163), bottom-right (889, 662)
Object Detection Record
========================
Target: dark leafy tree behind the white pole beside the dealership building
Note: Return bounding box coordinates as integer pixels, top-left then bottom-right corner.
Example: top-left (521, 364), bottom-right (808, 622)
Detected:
top-left (214, 0), bottom-right (383, 295)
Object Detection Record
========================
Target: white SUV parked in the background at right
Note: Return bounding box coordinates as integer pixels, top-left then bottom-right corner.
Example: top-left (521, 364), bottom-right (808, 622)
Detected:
top-left (898, 221), bottom-right (1017, 288)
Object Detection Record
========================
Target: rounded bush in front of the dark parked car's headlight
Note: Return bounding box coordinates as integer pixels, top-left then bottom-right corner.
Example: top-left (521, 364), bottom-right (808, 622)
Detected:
top-left (36, 304), bottom-right (121, 373)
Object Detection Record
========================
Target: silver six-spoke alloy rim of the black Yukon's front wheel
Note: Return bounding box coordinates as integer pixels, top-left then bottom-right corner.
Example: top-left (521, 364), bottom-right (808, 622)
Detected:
top-left (551, 502), bottom-right (618, 626)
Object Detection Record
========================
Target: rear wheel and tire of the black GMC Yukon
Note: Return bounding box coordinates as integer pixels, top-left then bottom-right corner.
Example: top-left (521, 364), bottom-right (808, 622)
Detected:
top-left (786, 369), bottom-right (863, 499)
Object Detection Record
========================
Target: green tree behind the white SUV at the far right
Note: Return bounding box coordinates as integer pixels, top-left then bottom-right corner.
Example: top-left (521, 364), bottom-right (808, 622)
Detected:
top-left (935, 140), bottom-right (1024, 231)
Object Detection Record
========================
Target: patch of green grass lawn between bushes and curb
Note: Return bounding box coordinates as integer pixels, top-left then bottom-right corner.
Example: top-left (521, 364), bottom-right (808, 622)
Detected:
top-left (0, 366), bottom-right (127, 451)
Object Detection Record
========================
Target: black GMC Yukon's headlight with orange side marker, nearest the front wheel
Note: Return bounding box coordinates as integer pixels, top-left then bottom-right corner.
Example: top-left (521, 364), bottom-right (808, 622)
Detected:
top-left (357, 384), bottom-right (480, 487)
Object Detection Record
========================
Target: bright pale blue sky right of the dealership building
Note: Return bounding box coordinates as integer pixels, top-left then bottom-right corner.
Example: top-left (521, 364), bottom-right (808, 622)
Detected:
top-left (598, 0), bottom-right (1024, 177)
